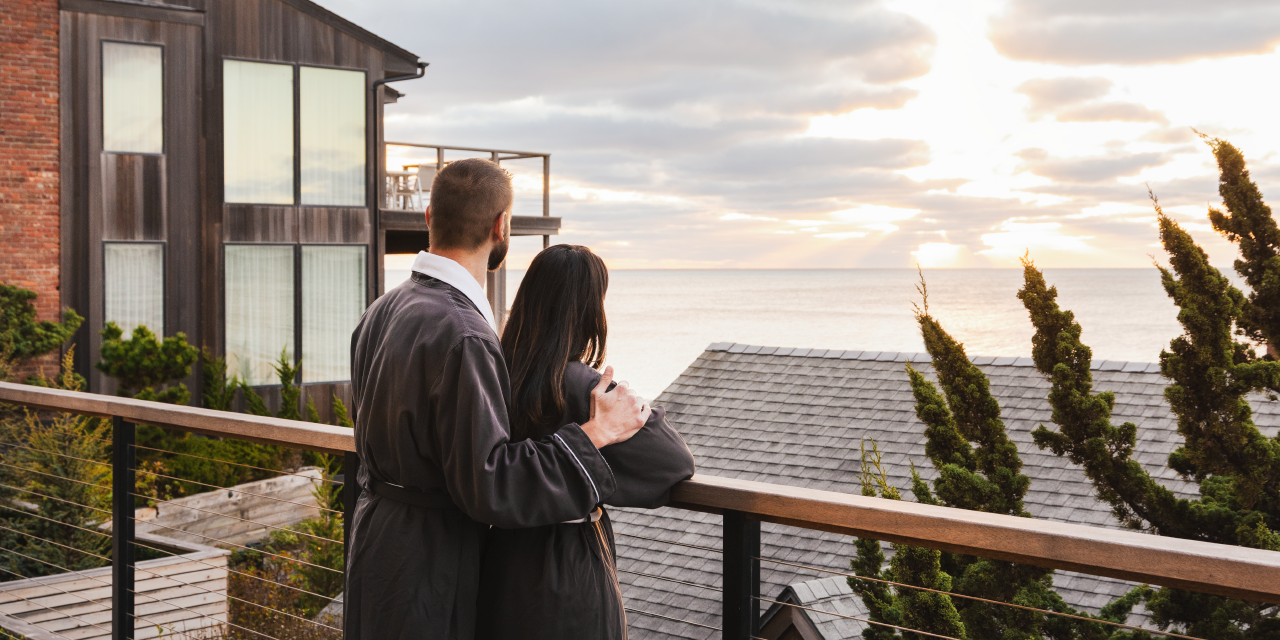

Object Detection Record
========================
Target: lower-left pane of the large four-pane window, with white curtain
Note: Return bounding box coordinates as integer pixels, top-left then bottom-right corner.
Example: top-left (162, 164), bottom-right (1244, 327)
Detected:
top-left (227, 244), bottom-right (293, 384)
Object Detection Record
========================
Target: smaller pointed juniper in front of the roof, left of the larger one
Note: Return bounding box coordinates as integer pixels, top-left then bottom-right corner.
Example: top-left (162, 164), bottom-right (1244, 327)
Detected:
top-left (850, 278), bottom-right (1134, 640)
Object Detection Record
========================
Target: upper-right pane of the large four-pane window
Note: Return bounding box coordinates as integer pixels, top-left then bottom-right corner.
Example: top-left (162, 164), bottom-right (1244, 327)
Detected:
top-left (298, 67), bottom-right (365, 206)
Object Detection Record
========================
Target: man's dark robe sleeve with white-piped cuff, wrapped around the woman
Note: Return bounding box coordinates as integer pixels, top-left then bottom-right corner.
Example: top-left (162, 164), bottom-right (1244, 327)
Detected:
top-left (419, 335), bottom-right (616, 529)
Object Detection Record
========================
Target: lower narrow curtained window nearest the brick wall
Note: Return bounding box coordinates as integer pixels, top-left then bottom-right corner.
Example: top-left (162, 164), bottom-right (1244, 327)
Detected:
top-left (102, 242), bottom-right (164, 337)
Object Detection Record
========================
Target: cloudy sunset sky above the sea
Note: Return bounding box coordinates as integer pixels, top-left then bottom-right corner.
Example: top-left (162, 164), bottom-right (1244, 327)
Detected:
top-left (321, 0), bottom-right (1280, 269)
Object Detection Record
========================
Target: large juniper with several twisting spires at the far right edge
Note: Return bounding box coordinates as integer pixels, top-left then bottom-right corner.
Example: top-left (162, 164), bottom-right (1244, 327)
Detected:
top-left (1019, 188), bottom-right (1280, 639)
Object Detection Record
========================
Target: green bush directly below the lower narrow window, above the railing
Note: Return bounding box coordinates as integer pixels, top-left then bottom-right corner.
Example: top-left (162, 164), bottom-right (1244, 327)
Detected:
top-left (96, 323), bottom-right (200, 404)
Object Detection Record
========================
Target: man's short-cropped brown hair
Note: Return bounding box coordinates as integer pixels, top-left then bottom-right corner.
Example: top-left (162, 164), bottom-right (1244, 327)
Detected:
top-left (430, 157), bottom-right (515, 250)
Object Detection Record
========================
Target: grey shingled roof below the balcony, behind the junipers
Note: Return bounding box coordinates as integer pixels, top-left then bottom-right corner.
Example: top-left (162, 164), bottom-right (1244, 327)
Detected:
top-left (611, 343), bottom-right (1280, 640)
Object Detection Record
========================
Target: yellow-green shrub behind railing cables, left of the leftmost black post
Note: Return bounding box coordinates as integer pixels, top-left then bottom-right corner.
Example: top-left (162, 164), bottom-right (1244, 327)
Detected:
top-left (0, 353), bottom-right (111, 580)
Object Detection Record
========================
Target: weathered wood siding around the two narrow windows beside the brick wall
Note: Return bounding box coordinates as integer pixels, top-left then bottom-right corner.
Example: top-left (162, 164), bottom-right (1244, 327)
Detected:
top-left (59, 10), bottom-right (204, 390)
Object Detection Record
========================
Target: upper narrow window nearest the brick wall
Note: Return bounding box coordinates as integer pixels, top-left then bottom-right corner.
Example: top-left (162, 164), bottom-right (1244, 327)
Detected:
top-left (102, 42), bottom-right (164, 154)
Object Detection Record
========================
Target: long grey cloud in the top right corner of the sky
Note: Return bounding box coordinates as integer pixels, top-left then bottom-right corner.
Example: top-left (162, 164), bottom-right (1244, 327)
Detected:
top-left (987, 0), bottom-right (1280, 65)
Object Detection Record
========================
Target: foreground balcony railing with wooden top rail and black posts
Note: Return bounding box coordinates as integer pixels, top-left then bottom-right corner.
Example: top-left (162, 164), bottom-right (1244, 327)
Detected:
top-left (0, 383), bottom-right (1280, 640)
